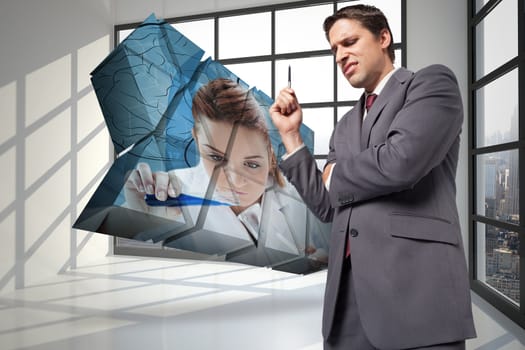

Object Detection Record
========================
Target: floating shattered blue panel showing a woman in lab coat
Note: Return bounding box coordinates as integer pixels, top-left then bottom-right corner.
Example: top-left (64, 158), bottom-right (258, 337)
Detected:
top-left (74, 15), bottom-right (330, 274)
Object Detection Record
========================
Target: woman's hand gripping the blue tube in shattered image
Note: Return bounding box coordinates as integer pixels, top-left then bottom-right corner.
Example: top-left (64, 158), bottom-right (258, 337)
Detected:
top-left (124, 163), bottom-right (182, 216)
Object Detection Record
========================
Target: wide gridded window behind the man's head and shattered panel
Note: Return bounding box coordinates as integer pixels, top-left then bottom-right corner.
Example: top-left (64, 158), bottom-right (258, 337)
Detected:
top-left (111, 0), bottom-right (406, 255)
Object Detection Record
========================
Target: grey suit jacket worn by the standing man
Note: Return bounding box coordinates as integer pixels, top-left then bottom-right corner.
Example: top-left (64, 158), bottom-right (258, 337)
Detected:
top-left (280, 65), bottom-right (475, 349)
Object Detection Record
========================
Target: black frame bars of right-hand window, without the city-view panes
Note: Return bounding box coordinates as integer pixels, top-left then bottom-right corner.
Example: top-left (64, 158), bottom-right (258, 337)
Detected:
top-left (467, 0), bottom-right (525, 328)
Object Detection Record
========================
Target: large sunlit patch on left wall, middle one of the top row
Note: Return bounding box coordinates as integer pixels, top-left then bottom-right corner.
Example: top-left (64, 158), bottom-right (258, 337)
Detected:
top-left (25, 54), bottom-right (71, 126)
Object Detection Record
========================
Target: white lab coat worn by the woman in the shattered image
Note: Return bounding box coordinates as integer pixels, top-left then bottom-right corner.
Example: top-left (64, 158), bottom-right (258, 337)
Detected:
top-left (162, 165), bottom-right (330, 262)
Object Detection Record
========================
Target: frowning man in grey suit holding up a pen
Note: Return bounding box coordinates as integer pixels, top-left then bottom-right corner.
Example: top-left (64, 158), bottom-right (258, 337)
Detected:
top-left (270, 5), bottom-right (476, 350)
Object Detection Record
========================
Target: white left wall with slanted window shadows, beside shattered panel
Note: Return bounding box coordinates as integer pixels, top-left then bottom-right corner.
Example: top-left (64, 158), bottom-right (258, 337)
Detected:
top-left (0, 0), bottom-right (114, 293)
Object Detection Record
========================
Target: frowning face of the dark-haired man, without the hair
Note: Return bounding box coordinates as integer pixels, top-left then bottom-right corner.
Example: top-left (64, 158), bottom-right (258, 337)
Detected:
top-left (328, 18), bottom-right (393, 92)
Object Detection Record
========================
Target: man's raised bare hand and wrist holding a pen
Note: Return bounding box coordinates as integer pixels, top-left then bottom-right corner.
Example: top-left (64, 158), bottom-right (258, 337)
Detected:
top-left (270, 88), bottom-right (303, 153)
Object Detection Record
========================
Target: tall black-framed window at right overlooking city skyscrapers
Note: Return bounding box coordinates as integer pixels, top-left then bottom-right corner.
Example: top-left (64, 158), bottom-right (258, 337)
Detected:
top-left (469, 0), bottom-right (525, 327)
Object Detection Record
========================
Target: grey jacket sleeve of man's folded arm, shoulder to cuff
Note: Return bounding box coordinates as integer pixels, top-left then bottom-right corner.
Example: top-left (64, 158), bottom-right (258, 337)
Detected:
top-left (330, 65), bottom-right (463, 207)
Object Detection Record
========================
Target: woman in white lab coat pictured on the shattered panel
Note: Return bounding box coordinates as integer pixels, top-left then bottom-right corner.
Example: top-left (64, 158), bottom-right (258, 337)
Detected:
top-left (125, 79), bottom-right (330, 273)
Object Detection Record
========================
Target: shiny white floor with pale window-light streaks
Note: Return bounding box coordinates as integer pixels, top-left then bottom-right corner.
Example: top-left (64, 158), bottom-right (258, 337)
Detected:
top-left (0, 257), bottom-right (525, 350)
